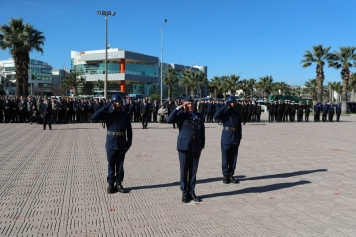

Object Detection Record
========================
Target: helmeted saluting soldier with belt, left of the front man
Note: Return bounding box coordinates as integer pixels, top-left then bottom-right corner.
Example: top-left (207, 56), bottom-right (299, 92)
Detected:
top-left (91, 95), bottom-right (132, 194)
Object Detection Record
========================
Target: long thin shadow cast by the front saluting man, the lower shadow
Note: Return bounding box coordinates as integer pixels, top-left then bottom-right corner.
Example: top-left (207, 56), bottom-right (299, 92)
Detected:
top-left (199, 181), bottom-right (311, 199)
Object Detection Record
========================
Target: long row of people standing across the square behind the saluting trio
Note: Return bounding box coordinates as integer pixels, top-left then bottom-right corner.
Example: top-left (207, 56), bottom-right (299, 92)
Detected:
top-left (0, 96), bottom-right (341, 125)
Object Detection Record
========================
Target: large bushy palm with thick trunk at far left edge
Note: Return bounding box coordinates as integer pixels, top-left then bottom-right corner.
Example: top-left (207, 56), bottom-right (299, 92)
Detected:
top-left (0, 18), bottom-right (45, 96)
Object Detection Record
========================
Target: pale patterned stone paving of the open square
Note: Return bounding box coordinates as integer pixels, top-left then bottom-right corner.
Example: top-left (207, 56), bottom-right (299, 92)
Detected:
top-left (0, 115), bottom-right (356, 236)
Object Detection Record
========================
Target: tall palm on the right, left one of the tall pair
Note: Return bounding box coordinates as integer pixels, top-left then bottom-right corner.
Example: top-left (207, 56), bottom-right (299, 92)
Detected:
top-left (301, 44), bottom-right (332, 101)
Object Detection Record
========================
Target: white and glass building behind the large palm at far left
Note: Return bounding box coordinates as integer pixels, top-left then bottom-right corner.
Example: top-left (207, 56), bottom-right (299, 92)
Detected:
top-left (0, 59), bottom-right (52, 96)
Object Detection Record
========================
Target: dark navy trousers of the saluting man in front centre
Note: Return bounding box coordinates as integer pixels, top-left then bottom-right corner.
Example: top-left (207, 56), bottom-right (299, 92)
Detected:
top-left (178, 150), bottom-right (200, 195)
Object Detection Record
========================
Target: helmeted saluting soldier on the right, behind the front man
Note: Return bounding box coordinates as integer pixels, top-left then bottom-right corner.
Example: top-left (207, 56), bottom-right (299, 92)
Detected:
top-left (214, 96), bottom-right (242, 184)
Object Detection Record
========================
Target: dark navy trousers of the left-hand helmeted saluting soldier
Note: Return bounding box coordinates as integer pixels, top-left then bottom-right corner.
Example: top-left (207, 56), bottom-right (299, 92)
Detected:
top-left (106, 150), bottom-right (125, 184)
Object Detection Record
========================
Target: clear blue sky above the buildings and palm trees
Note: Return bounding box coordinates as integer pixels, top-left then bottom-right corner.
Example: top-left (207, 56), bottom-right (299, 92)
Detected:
top-left (0, 0), bottom-right (356, 85)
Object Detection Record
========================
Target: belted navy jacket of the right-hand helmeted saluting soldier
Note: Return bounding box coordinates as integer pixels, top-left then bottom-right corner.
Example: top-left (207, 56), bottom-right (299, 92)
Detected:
top-left (214, 104), bottom-right (242, 145)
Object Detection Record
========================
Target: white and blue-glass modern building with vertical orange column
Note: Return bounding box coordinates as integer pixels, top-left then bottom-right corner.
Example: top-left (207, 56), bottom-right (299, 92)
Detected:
top-left (71, 48), bottom-right (207, 95)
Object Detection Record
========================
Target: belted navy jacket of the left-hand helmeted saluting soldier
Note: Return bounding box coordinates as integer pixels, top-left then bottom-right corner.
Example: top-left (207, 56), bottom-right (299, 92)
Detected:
top-left (91, 103), bottom-right (132, 151)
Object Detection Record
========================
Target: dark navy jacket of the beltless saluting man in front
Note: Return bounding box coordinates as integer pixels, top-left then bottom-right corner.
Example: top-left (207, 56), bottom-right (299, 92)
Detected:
top-left (167, 109), bottom-right (205, 152)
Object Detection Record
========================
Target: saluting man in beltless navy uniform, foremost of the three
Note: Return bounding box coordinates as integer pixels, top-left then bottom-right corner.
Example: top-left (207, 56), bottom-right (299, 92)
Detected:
top-left (167, 96), bottom-right (205, 203)
